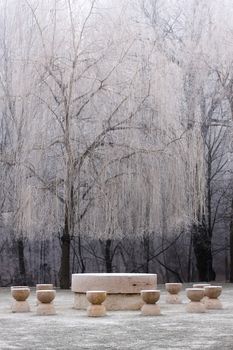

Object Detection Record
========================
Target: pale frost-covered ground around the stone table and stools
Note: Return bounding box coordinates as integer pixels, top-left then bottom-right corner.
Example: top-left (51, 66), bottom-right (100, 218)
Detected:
top-left (0, 285), bottom-right (233, 350)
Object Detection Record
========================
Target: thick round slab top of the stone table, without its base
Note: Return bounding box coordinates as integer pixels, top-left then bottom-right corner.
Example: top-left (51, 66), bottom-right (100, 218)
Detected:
top-left (71, 273), bottom-right (157, 294)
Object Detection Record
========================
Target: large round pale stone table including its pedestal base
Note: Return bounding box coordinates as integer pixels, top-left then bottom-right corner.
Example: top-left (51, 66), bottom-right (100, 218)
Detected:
top-left (71, 273), bottom-right (157, 310)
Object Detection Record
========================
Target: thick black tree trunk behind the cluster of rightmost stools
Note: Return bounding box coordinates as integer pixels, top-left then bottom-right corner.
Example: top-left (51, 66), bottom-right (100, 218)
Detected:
top-left (193, 224), bottom-right (216, 282)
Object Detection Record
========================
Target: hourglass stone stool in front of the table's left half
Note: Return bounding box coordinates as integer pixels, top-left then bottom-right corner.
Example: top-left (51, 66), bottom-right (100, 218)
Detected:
top-left (86, 291), bottom-right (107, 317)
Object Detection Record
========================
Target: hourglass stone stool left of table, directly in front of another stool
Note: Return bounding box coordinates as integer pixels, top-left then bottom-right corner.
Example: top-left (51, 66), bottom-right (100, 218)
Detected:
top-left (36, 290), bottom-right (56, 316)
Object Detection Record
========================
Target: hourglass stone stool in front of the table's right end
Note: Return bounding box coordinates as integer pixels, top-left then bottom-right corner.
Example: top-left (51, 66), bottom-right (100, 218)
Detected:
top-left (141, 289), bottom-right (160, 316)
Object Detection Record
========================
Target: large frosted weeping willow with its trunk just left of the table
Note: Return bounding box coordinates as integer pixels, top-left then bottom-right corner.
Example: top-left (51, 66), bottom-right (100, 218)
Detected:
top-left (1, 0), bottom-right (204, 288)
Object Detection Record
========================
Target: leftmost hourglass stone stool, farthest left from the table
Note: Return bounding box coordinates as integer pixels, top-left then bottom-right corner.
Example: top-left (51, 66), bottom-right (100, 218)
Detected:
top-left (11, 286), bottom-right (30, 312)
